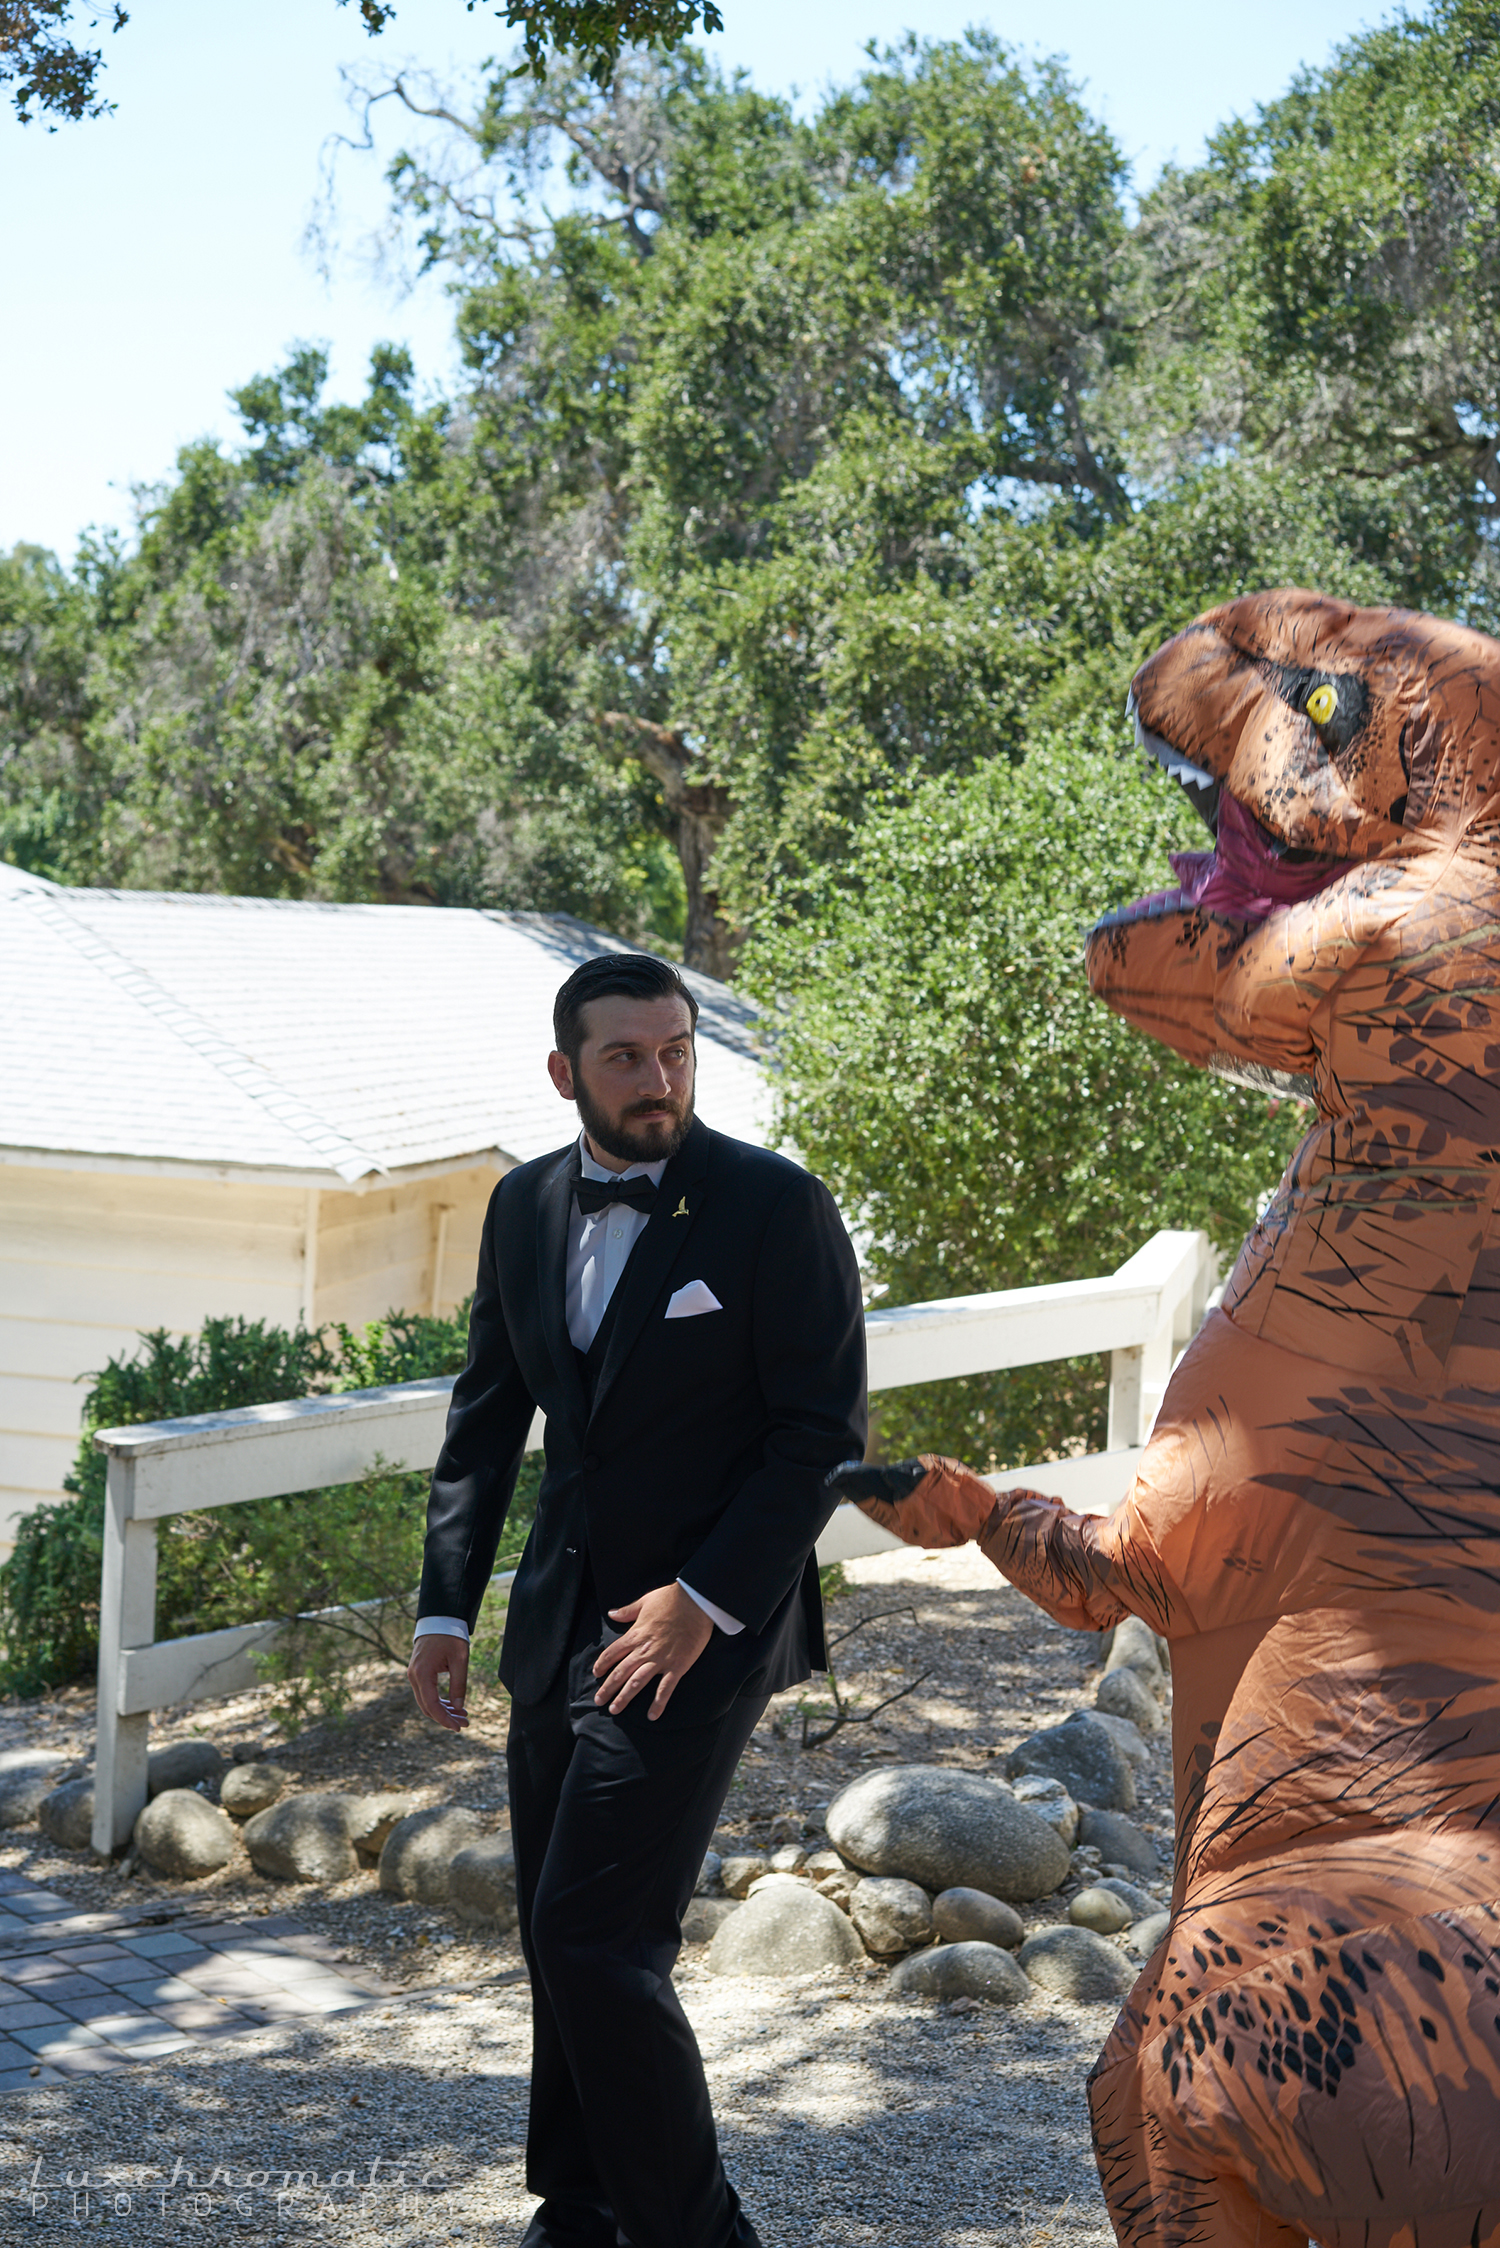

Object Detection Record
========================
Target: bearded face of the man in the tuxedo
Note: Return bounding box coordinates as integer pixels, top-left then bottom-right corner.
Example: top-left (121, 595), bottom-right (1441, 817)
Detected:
top-left (546, 994), bottom-right (693, 1169)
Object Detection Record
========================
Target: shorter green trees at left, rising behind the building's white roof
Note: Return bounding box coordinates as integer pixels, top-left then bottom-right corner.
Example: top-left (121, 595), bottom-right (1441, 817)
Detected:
top-left (0, 348), bottom-right (681, 944)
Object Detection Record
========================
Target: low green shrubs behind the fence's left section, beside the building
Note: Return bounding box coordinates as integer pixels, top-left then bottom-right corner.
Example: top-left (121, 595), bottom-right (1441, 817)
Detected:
top-left (0, 1306), bottom-right (537, 1724)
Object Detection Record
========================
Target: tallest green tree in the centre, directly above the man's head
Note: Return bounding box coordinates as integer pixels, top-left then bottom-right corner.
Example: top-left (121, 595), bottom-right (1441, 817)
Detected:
top-left (355, 36), bottom-right (1133, 973)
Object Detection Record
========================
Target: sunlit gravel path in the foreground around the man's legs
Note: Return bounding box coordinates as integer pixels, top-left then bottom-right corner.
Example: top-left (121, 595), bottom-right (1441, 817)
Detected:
top-left (0, 1967), bottom-right (1111, 2248)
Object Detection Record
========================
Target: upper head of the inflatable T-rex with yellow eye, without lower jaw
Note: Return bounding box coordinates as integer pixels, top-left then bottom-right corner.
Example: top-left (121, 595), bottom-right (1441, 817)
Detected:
top-left (1127, 589), bottom-right (1500, 919)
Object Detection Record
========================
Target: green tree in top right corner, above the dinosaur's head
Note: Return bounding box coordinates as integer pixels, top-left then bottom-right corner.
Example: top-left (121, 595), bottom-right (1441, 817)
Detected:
top-left (1115, 0), bottom-right (1500, 623)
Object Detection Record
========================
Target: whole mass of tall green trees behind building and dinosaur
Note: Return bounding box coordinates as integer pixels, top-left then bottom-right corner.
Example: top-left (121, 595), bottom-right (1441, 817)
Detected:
top-left (11, 17), bottom-right (1500, 948)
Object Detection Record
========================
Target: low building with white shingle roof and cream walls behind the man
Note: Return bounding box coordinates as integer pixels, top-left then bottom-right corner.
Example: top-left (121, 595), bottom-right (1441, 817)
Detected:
top-left (0, 865), bottom-right (769, 1549)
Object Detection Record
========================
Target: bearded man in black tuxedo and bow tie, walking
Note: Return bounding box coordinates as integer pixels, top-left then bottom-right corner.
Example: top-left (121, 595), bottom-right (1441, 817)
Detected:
top-left (412, 953), bottom-right (866, 2248)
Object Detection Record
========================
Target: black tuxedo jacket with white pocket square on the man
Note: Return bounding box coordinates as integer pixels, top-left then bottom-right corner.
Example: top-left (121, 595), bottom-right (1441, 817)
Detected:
top-left (418, 1122), bottom-right (866, 1724)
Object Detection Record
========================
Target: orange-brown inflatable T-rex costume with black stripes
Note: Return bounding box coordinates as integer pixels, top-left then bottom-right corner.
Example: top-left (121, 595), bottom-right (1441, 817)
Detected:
top-left (850, 591), bottom-right (1500, 2248)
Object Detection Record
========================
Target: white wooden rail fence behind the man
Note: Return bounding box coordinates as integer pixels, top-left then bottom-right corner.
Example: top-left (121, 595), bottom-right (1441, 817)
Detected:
top-left (94, 1232), bottom-right (1214, 1852)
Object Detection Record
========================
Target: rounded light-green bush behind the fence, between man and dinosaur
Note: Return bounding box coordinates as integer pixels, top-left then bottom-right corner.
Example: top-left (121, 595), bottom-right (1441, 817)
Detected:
top-left (747, 726), bottom-right (1300, 1463)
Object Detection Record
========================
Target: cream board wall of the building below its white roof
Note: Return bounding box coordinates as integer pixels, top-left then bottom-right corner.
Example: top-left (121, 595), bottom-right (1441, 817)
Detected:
top-left (0, 1164), bottom-right (497, 1558)
